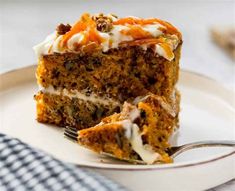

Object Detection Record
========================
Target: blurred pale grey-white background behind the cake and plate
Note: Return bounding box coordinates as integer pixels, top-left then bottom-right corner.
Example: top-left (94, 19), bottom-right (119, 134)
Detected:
top-left (0, 0), bottom-right (235, 89)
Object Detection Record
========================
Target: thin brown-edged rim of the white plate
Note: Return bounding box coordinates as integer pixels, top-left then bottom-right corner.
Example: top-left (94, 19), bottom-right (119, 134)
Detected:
top-left (0, 64), bottom-right (235, 171)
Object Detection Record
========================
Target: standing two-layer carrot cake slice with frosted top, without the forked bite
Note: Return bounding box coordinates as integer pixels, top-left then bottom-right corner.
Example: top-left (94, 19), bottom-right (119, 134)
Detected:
top-left (34, 13), bottom-right (182, 129)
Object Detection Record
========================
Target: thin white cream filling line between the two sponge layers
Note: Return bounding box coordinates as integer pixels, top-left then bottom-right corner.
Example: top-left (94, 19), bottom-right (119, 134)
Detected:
top-left (41, 86), bottom-right (120, 105)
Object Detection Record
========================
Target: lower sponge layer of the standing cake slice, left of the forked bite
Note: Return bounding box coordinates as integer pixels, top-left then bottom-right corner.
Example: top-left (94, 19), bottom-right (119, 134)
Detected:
top-left (35, 90), bottom-right (121, 129)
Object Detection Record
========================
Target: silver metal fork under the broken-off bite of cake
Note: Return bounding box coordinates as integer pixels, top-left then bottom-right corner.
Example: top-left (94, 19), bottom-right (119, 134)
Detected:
top-left (64, 127), bottom-right (235, 164)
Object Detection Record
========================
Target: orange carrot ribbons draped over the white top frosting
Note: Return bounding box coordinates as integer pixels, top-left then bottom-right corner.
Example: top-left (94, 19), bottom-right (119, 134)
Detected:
top-left (54, 13), bottom-right (182, 59)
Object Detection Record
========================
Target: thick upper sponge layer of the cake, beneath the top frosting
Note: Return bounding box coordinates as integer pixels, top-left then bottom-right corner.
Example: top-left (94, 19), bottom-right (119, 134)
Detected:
top-left (37, 45), bottom-right (181, 103)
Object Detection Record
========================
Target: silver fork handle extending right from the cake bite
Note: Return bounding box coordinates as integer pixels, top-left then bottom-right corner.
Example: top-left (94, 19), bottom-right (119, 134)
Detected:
top-left (171, 140), bottom-right (235, 158)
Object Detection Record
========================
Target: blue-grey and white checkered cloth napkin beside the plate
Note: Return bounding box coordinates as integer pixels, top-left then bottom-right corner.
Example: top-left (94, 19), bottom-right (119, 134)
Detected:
top-left (0, 133), bottom-right (125, 191)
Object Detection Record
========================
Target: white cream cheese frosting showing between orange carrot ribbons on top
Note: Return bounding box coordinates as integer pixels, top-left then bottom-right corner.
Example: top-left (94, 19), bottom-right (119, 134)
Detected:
top-left (34, 13), bottom-right (180, 61)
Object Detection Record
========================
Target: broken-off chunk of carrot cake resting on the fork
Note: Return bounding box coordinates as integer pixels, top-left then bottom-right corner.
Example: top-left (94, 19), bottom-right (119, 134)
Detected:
top-left (78, 92), bottom-right (179, 164)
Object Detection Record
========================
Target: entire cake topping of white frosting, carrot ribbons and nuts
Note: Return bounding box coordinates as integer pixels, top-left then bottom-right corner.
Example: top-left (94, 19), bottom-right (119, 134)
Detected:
top-left (34, 13), bottom-right (182, 61)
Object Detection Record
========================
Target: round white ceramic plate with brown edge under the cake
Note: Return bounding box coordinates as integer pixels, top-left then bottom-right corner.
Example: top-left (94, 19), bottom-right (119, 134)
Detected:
top-left (0, 66), bottom-right (235, 190)
